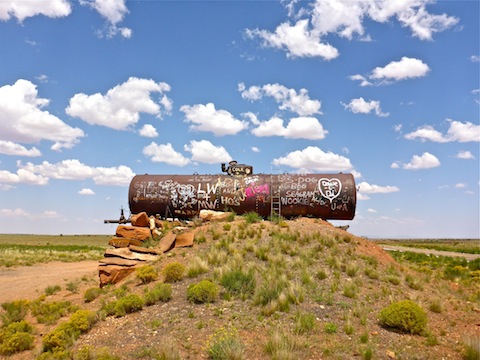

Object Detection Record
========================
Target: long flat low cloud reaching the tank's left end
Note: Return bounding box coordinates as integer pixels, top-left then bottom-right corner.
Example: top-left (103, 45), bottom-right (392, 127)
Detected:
top-left (17, 159), bottom-right (135, 186)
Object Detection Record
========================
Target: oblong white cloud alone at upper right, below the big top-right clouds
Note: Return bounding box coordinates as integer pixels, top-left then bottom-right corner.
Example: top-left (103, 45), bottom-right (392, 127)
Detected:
top-left (350, 56), bottom-right (430, 86)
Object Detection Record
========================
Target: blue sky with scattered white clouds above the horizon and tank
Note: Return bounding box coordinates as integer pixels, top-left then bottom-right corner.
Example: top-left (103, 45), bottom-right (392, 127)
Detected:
top-left (0, 0), bottom-right (480, 238)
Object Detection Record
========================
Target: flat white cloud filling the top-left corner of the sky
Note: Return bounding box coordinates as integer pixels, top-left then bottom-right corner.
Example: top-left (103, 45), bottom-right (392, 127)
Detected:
top-left (0, 0), bottom-right (72, 23)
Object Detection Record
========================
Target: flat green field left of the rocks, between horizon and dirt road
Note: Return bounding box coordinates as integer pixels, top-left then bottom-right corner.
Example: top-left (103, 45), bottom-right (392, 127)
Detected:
top-left (0, 234), bottom-right (111, 267)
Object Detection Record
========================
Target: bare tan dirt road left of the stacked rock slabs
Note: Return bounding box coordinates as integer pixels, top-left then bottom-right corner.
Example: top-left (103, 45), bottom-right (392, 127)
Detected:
top-left (0, 261), bottom-right (98, 304)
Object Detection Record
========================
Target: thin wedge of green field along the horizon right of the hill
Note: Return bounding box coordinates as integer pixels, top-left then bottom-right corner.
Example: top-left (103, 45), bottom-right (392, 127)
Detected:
top-left (372, 239), bottom-right (480, 254)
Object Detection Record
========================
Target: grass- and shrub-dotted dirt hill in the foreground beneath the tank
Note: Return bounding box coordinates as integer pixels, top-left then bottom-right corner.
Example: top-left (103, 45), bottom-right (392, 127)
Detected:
top-left (0, 214), bottom-right (480, 359)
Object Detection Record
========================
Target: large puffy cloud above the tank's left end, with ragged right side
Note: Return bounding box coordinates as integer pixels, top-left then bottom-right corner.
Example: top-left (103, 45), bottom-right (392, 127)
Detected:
top-left (65, 77), bottom-right (172, 130)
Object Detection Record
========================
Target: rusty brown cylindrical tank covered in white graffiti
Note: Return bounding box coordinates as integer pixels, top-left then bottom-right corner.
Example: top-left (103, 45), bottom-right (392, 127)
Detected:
top-left (128, 173), bottom-right (357, 220)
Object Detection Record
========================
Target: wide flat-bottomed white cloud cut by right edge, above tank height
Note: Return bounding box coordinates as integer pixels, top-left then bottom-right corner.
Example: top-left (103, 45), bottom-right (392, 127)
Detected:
top-left (405, 119), bottom-right (480, 143)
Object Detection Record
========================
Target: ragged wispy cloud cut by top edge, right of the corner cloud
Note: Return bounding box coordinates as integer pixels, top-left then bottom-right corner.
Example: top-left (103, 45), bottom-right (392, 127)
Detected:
top-left (80, 0), bottom-right (132, 38)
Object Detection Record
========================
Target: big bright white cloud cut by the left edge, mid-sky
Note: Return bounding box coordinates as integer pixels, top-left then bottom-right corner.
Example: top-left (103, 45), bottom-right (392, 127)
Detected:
top-left (0, 79), bottom-right (84, 150)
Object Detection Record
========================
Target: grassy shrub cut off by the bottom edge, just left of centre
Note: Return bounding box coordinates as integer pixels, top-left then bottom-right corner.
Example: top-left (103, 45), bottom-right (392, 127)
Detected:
top-left (208, 329), bottom-right (245, 360)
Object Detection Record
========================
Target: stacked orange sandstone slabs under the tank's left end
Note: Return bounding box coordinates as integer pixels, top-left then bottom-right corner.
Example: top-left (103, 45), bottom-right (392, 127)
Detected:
top-left (98, 210), bottom-right (230, 287)
